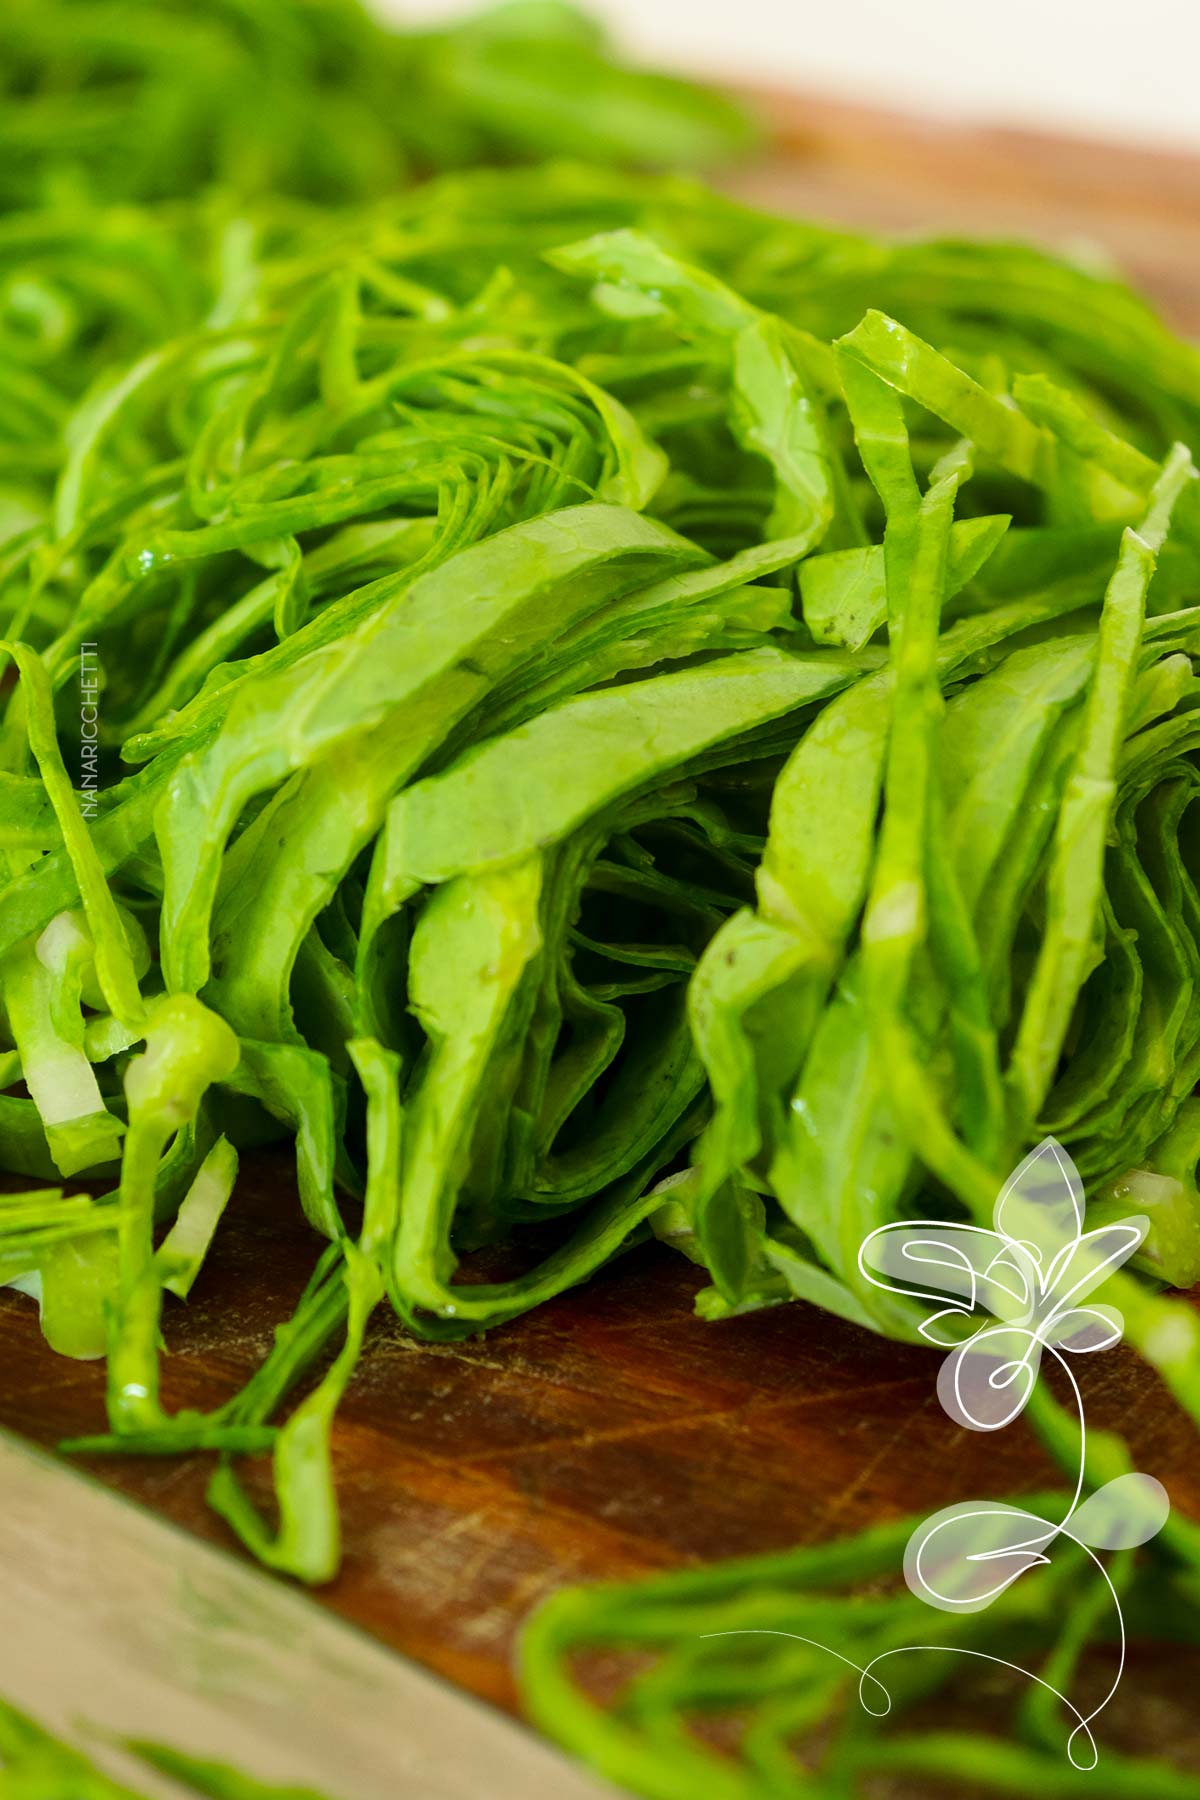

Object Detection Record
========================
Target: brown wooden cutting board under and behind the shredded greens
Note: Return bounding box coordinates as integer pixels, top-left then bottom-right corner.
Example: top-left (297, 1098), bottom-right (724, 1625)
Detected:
top-left (0, 84), bottom-right (1200, 1769)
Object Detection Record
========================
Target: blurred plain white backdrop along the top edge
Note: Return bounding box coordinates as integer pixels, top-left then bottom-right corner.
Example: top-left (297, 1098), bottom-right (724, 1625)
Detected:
top-left (376, 0), bottom-right (1200, 149)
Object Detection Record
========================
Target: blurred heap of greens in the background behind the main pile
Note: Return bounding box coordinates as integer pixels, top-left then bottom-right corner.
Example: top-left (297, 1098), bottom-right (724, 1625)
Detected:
top-left (0, 0), bottom-right (756, 211)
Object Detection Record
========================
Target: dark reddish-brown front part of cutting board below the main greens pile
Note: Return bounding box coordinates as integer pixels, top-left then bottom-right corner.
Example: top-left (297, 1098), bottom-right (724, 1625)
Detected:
top-left (0, 1157), bottom-right (1200, 1706)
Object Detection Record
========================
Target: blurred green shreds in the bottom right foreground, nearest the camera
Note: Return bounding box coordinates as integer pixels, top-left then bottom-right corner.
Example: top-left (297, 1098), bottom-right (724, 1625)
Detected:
top-left (522, 1494), bottom-right (1196, 1800)
